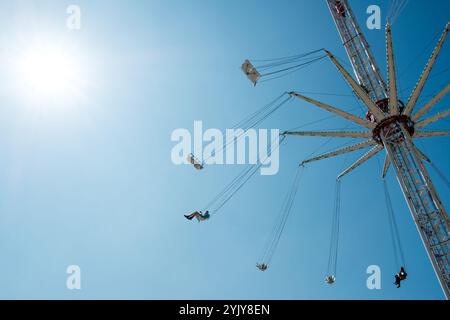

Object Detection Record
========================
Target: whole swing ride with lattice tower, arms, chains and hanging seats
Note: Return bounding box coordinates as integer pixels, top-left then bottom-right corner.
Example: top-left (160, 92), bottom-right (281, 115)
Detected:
top-left (185, 0), bottom-right (450, 299)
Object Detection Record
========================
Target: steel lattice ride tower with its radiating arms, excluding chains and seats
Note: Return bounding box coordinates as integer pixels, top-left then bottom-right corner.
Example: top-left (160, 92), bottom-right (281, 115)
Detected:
top-left (286, 0), bottom-right (450, 299)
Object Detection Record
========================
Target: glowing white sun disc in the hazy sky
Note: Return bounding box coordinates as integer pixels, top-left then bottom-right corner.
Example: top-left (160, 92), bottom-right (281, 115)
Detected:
top-left (17, 47), bottom-right (80, 98)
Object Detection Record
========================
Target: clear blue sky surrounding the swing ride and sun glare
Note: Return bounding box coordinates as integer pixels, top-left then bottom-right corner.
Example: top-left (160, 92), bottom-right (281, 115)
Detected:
top-left (0, 0), bottom-right (450, 299)
